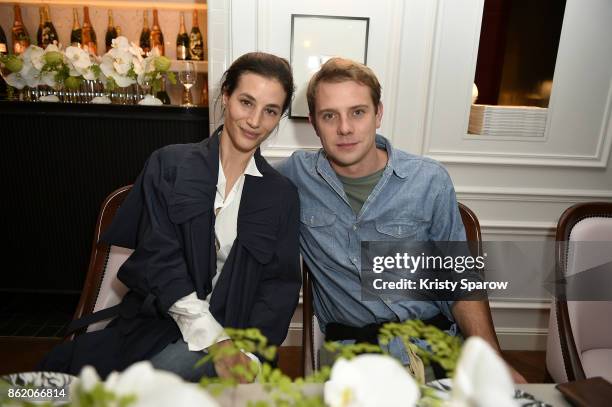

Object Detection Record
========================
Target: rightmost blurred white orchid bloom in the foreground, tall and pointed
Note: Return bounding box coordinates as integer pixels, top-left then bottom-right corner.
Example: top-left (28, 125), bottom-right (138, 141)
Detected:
top-left (451, 336), bottom-right (518, 407)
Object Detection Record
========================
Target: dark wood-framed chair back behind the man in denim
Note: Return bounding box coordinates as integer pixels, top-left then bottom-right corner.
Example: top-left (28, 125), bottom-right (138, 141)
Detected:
top-left (302, 203), bottom-right (482, 375)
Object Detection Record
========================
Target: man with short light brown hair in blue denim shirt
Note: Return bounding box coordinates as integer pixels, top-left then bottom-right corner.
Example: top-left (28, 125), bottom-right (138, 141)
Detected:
top-left (279, 58), bottom-right (524, 382)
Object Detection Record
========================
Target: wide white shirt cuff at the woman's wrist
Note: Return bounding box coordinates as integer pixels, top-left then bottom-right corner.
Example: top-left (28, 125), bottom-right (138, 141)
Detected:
top-left (168, 292), bottom-right (229, 351)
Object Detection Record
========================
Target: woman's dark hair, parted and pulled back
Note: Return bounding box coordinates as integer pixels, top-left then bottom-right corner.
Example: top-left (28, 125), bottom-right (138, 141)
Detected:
top-left (219, 52), bottom-right (294, 113)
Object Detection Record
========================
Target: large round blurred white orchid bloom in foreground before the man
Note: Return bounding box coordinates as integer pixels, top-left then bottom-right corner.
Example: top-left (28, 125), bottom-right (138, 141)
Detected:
top-left (324, 354), bottom-right (420, 407)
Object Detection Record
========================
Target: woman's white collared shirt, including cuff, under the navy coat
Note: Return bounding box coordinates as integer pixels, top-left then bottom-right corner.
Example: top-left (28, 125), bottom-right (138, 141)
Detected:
top-left (168, 156), bottom-right (263, 357)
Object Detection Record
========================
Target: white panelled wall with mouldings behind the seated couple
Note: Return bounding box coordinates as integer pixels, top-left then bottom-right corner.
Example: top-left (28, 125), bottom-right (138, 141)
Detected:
top-left (208, 0), bottom-right (612, 349)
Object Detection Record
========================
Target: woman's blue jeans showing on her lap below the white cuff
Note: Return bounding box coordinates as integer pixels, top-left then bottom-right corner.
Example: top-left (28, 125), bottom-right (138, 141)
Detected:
top-left (150, 339), bottom-right (217, 382)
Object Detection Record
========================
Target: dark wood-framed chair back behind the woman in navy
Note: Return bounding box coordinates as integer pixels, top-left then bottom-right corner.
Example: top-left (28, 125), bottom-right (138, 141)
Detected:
top-left (74, 185), bottom-right (132, 335)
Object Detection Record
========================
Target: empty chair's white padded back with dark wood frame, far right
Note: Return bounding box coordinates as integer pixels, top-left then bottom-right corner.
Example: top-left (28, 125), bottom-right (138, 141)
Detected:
top-left (546, 202), bottom-right (612, 382)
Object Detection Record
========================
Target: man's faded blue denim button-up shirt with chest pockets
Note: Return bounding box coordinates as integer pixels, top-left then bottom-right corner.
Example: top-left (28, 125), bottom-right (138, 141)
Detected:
top-left (277, 135), bottom-right (465, 330)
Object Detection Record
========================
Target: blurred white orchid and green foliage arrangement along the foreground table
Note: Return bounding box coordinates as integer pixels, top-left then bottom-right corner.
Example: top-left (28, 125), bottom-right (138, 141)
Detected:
top-left (0, 321), bottom-right (518, 407)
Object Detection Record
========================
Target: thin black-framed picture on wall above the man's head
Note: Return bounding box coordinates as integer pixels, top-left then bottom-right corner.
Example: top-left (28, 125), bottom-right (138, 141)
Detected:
top-left (289, 14), bottom-right (370, 119)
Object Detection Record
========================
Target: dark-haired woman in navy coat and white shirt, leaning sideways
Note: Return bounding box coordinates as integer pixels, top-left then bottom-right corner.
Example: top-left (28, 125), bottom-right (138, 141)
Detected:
top-left (42, 53), bottom-right (301, 381)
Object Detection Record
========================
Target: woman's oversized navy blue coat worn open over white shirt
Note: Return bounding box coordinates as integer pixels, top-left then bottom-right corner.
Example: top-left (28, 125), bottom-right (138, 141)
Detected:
top-left (41, 128), bottom-right (301, 377)
